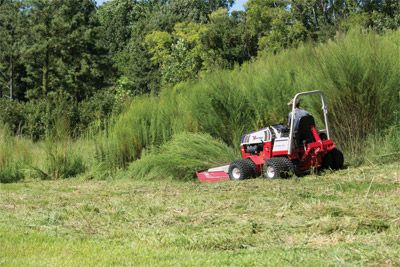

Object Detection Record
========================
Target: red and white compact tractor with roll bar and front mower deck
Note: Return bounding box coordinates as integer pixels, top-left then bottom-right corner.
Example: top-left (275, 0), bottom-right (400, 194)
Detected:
top-left (197, 91), bottom-right (344, 182)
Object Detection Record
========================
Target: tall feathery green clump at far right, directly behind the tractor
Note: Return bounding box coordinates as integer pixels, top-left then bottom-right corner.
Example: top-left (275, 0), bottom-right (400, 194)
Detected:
top-left (299, 30), bottom-right (400, 157)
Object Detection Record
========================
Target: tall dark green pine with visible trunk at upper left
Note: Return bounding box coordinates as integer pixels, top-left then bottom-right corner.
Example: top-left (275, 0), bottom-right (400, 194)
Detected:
top-left (24, 0), bottom-right (109, 101)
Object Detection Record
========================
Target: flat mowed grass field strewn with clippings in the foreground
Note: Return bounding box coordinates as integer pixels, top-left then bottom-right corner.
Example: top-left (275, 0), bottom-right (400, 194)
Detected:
top-left (0, 163), bottom-right (400, 266)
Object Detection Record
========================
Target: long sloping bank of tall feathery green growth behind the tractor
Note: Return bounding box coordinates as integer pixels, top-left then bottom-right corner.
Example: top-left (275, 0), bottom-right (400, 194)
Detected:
top-left (96, 30), bottom-right (400, 172)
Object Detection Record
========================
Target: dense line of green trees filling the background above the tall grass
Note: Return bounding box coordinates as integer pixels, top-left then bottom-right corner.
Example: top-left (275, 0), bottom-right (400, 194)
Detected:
top-left (0, 0), bottom-right (400, 140)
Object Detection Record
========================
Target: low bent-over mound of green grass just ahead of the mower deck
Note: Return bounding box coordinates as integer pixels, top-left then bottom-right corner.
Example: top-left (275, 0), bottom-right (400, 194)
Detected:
top-left (128, 133), bottom-right (238, 180)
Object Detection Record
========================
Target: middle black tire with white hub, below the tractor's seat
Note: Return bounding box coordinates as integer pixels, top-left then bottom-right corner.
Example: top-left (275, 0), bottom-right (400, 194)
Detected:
top-left (264, 157), bottom-right (294, 179)
